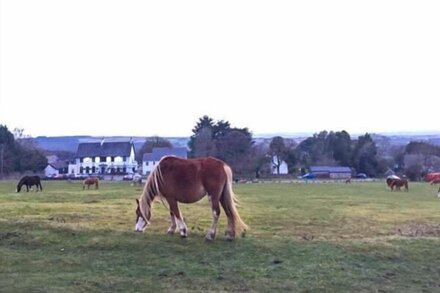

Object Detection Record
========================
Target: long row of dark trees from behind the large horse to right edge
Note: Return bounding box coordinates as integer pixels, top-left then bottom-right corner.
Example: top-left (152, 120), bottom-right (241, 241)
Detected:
top-left (188, 116), bottom-right (440, 180)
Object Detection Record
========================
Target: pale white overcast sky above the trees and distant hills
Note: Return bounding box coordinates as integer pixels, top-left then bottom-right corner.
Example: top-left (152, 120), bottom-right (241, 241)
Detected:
top-left (0, 0), bottom-right (440, 136)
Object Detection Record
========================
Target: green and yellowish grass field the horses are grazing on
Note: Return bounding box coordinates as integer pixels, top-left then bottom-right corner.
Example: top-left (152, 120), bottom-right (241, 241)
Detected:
top-left (0, 181), bottom-right (440, 292)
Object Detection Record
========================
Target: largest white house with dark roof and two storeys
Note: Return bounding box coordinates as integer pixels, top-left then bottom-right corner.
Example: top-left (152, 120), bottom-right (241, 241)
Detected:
top-left (69, 139), bottom-right (138, 175)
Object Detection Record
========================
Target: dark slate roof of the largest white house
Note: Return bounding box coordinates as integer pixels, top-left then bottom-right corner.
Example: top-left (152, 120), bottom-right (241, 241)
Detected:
top-left (76, 141), bottom-right (133, 158)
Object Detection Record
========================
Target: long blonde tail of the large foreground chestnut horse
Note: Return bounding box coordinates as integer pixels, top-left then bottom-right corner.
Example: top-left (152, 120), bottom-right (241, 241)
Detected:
top-left (220, 165), bottom-right (248, 231)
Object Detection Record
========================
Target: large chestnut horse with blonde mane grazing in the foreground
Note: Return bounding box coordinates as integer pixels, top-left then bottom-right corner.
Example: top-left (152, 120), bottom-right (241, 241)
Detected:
top-left (135, 156), bottom-right (247, 240)
